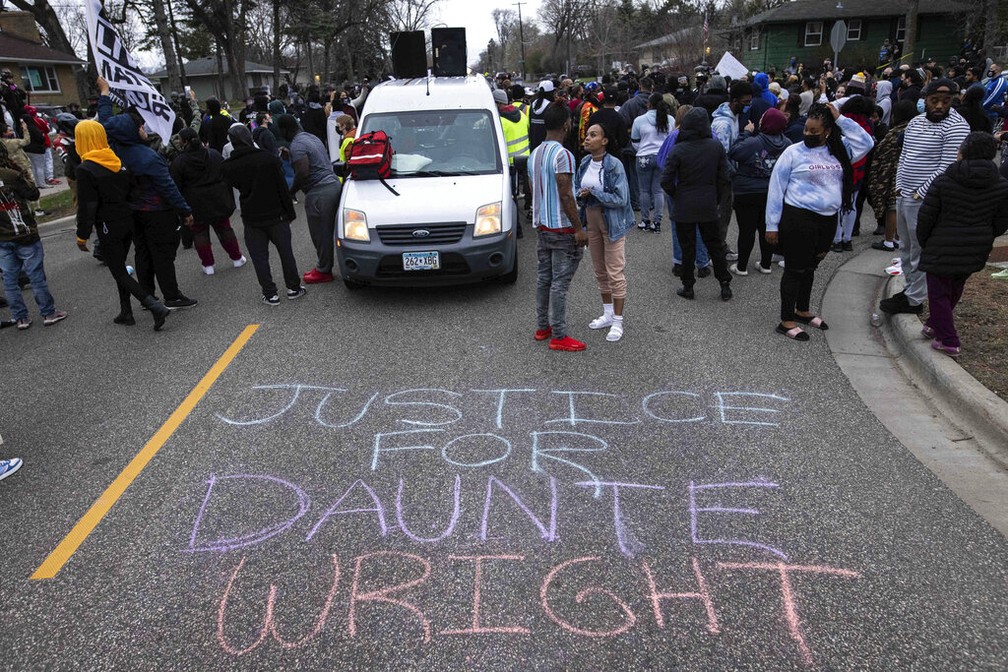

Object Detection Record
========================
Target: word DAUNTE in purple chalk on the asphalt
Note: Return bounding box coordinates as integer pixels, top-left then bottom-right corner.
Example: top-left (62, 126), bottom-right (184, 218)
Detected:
top-left (185, 474), bottom-right (788, 560)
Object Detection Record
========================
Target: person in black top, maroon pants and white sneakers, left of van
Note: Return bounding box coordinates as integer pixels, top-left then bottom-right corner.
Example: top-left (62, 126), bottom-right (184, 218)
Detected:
top-left (171, 128), bottom-right (245, 275)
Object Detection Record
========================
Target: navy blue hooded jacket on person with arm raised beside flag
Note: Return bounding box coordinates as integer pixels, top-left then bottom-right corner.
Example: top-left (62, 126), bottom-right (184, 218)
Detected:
top-left (98, 96), bottom-right (193, 217)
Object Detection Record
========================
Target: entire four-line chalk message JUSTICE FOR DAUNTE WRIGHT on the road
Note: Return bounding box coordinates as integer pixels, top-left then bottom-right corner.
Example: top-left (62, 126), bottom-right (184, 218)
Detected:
top-left (190, 383), bottom-right (860, 666)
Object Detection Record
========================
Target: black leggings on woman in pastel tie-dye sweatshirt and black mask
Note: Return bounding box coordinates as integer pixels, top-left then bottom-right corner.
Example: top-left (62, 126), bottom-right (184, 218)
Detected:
top-left (778, 204), bottom-right (837, 322)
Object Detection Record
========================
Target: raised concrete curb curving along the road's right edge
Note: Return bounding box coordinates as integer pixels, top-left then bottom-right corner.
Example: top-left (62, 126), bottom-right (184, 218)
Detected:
top-left (880, 276), bottom-right (1008, 468)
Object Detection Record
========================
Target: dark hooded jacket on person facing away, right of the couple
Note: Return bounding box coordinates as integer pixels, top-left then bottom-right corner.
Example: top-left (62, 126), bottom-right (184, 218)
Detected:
top-left (661, 107), bottom-right (732, 224)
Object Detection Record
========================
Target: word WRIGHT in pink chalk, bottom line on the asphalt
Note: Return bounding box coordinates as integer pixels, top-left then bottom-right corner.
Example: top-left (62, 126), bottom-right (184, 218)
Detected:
top-left (217, 551), bottom-right (860, 666)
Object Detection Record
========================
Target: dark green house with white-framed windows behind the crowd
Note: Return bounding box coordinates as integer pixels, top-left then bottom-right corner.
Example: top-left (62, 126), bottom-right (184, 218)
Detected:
top-left (726, 0), bottom-right (969, 72)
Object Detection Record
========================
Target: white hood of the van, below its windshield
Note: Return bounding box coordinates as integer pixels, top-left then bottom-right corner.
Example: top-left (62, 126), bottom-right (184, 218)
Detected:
top-left (341, 174), bottom-right (511, 229)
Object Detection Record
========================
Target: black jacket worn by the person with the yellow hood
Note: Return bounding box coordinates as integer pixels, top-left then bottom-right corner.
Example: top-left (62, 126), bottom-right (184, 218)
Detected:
top-left (77, 161), bottom-right (133, 240)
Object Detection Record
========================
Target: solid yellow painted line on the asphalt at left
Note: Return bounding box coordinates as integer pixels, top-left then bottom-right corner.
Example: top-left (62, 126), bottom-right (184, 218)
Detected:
top-left (31, 324), bottom-right (259, 580)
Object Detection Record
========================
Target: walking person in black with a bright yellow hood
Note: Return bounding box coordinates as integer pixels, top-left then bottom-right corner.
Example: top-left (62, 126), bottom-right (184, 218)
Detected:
top-left (75, 121), bottom-right (168, 331)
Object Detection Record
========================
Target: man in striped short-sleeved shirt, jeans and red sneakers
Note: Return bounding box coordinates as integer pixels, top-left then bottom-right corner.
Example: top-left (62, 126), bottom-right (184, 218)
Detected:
top-left (528, 102), bottom-right (588, 352)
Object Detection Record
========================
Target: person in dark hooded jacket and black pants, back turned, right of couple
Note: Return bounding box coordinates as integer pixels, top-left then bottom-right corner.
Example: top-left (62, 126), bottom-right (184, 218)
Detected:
top-left (661, 107), bottom-right (732, 301)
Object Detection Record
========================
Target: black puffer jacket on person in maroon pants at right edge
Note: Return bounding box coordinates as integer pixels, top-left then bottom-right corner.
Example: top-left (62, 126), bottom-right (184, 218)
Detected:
top-left (917, 159), bottom-right (1008, 276)
